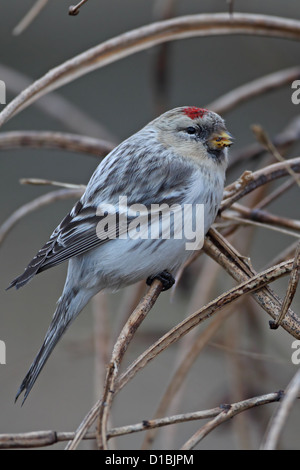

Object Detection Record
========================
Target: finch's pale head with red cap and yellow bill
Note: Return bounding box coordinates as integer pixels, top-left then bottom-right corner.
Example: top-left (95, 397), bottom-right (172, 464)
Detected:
top-left (151, 106), bottom-right (233, 166)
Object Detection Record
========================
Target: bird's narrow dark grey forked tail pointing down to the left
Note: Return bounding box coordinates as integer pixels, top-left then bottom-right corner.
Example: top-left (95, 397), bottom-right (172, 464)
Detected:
top-left (15, 289), bottom-right (85, 405)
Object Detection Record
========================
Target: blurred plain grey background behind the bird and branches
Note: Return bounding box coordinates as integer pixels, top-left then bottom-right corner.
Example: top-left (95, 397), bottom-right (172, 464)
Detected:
top-left (0, 0), bottom-right (300, 449)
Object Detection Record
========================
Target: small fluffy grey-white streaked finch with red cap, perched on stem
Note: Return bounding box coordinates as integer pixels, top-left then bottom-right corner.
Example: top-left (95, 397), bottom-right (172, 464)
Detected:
top-left (9, 106), bottom-right (232, 403)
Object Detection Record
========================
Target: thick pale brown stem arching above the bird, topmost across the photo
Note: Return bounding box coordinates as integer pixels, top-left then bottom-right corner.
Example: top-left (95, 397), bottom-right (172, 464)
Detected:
top-left (0, 13), bottom-right (300, 126)
